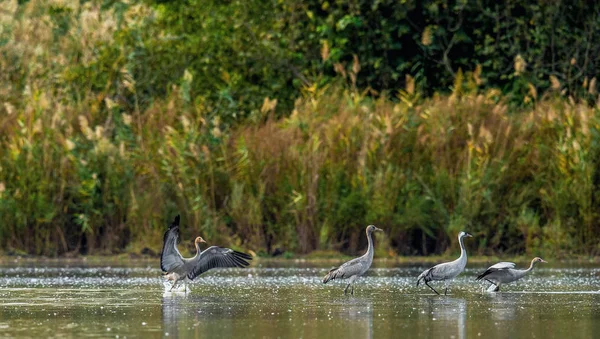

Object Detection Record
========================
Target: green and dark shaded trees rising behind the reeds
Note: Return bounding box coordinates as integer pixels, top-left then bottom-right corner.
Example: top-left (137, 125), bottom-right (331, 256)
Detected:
top-left (138, 0), bottom-right (600, 123)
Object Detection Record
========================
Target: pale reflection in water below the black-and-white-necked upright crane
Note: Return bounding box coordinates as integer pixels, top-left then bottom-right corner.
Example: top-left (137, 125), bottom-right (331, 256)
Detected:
top-left (420, 296), bottom-right (467, 339)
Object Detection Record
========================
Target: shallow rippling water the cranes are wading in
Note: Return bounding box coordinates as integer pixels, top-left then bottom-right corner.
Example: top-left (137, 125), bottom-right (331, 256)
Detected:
top-left (0, 262), bottom-right (600, 338)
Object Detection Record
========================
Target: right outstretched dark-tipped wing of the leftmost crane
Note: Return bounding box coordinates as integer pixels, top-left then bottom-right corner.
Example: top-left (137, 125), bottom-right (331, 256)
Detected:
top-left (188, 246), bottom-right (252, 280)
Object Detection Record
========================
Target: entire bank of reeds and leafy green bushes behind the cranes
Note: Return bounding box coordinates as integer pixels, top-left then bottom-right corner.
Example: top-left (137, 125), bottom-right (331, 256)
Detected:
top-left (0, 0), bottom-right (600, 260)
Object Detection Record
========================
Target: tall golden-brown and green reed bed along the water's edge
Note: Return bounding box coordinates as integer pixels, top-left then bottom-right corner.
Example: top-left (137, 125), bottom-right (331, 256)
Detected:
top-left (0, 0), bottom-right (600, 257)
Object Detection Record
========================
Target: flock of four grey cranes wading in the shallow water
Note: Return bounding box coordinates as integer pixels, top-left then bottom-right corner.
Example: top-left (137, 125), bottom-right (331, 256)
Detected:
top-left (160, 215), bottom-right (546, 295)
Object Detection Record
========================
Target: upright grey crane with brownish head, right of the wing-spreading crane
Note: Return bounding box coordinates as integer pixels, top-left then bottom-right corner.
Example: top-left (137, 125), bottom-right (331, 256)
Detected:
top-left (323, 225), bottom-right (383, 295)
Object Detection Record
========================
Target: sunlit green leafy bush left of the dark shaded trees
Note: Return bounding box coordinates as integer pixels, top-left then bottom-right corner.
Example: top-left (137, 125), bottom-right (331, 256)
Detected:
top-left (131, 0), bottom-right (308, 123)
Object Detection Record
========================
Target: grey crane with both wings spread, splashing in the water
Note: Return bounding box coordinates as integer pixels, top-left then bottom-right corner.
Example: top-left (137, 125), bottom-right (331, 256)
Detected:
top-left (160, 215), bottom-right (252, 291)
